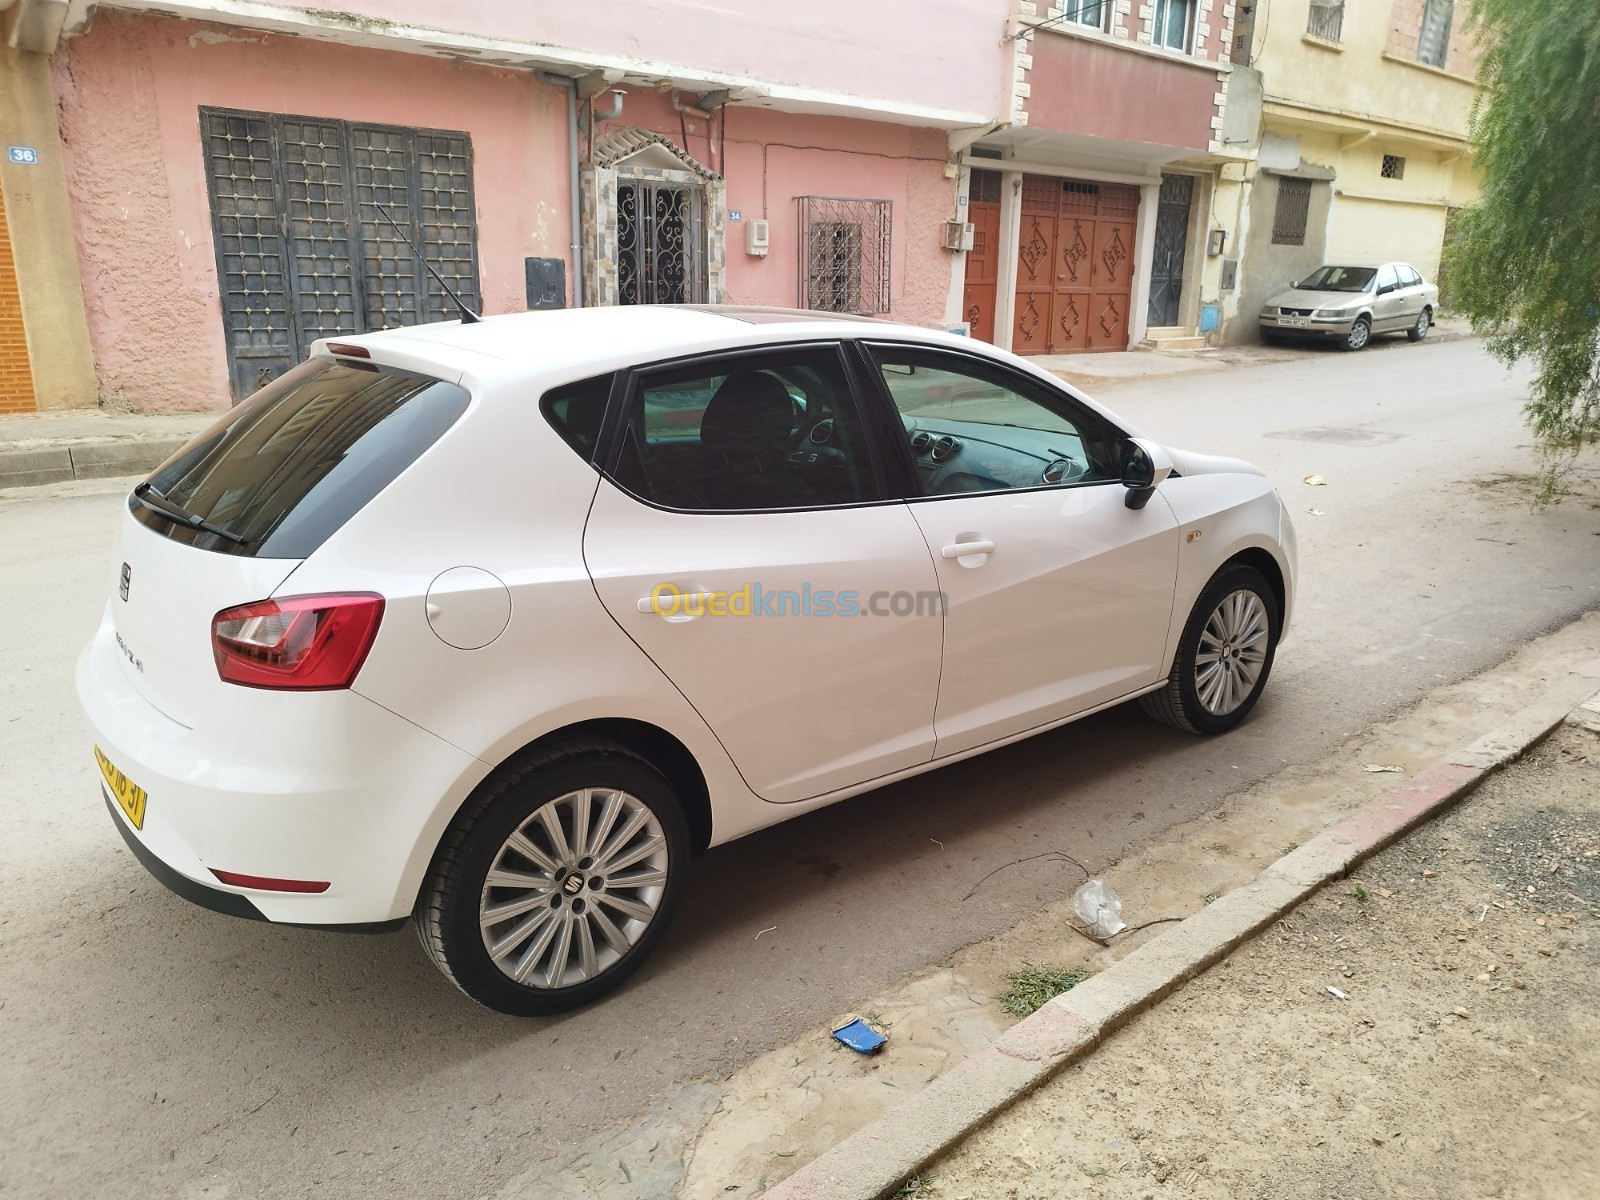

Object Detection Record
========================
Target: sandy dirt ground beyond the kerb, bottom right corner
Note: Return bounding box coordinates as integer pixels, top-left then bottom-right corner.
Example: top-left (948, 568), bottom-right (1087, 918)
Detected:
top-left (928, 726), bottom-right (1600, 1200)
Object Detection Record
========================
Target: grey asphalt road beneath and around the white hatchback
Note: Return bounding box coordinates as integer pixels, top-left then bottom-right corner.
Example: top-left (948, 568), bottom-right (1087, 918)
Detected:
top-left (0, 342), bottom-right (1600, 1200)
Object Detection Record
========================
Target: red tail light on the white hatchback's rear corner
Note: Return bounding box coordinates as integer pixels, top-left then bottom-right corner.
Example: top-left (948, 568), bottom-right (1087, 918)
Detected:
top-left (211, 592), bottom-right (384, 691)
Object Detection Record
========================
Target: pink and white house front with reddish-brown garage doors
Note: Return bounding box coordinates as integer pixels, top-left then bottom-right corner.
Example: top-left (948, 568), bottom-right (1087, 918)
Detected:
top-left (960, 0), bottom-right (1261, 355)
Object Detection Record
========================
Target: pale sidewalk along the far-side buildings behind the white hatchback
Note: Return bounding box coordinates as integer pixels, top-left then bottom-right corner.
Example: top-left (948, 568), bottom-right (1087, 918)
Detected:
top-left (0, 317), bottom-right (1472, 488)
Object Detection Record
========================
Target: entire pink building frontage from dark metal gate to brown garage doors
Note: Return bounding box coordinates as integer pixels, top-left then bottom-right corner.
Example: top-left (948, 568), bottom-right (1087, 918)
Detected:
top-left (19, 0), bottom-right (1254, 411)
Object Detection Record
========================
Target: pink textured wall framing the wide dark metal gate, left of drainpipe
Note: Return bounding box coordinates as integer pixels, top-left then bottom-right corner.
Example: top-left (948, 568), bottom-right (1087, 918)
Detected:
top-left (53, 11), bottom-right (571, 411)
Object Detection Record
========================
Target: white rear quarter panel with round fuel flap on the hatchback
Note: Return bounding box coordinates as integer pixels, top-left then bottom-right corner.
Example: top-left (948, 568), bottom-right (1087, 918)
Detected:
top-left (278, 377), bottom-right (747, 893)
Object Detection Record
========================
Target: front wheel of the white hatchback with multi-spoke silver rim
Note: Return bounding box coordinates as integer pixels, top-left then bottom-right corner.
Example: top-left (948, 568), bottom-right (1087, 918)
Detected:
top-left (1141, 563), bottom-right (1280, 733)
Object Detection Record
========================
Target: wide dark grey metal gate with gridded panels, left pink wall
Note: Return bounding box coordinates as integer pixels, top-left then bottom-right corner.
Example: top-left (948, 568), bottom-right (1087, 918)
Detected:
top-left (200, 109), bottom-right (478, 400)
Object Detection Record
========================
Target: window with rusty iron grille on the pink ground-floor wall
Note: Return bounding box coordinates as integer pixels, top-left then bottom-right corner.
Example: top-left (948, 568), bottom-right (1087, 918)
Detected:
top-left (797, 195), bottom-right (893, 314)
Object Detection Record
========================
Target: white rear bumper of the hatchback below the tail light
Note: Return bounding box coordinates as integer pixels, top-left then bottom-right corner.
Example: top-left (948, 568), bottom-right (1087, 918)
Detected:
top-left (77, 611), bottom-right (486, 930)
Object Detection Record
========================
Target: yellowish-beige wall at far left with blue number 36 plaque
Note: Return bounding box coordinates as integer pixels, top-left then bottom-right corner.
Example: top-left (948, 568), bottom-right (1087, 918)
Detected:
top-left (0, 46), bottom-right (96, 411)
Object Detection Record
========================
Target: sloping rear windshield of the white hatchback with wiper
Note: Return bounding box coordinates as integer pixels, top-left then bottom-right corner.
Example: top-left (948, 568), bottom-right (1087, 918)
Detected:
top-left (128, 358), bottom-right (469, 558)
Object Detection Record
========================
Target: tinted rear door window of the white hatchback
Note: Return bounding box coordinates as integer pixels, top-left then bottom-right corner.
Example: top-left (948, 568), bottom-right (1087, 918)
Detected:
top-left (616, 346), bottom-right (878, 510)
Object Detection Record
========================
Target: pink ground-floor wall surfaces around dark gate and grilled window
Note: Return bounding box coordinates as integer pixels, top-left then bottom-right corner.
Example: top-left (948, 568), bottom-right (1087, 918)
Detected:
top-left (54, 11), bottom-right (955, 411)
